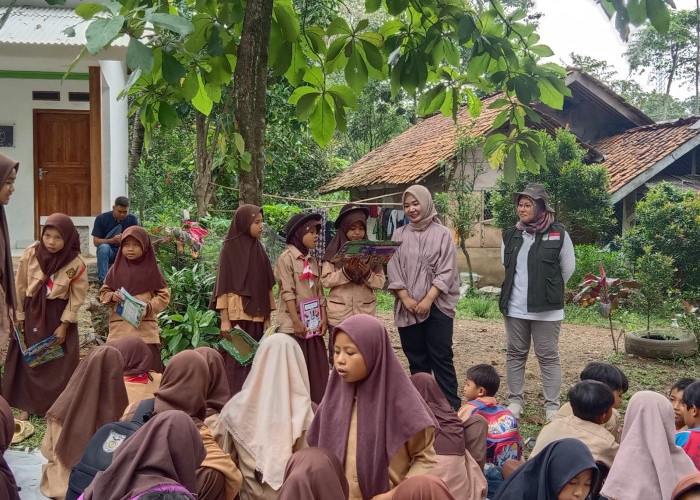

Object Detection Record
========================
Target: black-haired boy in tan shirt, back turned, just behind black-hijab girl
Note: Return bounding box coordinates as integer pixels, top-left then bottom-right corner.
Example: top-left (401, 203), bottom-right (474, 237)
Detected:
top-left (530, 380), bottom-right (620, 467)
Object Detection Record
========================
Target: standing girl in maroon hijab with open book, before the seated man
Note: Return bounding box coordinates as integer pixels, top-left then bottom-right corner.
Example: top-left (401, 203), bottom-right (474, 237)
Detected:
top-left (100, 226), bottom-right (170, 373)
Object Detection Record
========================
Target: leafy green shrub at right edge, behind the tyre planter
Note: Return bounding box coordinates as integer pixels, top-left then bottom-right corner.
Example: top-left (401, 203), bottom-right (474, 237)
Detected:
top-left (621, 182), bottom-right (700, 295)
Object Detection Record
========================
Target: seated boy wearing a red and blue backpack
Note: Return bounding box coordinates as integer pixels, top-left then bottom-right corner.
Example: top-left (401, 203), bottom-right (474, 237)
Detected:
top-left (458, 364), bottom-right (523, 498)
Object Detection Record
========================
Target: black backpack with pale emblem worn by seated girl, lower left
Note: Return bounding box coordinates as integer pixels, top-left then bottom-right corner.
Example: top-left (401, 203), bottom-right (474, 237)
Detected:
top-left (66, 398), bottom-right (155, 500)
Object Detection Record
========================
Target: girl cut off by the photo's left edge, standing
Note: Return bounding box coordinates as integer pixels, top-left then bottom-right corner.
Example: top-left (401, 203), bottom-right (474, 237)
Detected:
top-left (0, 153), bottom-right (19, 361)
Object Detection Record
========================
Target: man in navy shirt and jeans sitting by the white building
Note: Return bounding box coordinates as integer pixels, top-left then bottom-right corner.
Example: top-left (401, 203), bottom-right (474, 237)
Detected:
top-left (92, 196), bottom-right (139, 288)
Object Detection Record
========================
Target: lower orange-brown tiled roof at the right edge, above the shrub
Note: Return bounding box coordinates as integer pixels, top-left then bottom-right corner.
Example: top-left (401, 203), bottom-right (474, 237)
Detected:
top-left (593, 117), bottom-right (700, 193)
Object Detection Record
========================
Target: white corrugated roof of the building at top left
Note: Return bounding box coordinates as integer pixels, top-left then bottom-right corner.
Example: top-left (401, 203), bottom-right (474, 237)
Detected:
top-left (0, 7), bottom-right (129, 47)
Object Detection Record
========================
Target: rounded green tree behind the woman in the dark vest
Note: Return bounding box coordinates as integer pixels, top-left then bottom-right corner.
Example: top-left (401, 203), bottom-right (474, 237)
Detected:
top-left (492, 129), bottom-right (613, 243)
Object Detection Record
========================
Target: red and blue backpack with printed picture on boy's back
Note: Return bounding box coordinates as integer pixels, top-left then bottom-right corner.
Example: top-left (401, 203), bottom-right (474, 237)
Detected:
top-left (469, 399), bottom-right (523, 467)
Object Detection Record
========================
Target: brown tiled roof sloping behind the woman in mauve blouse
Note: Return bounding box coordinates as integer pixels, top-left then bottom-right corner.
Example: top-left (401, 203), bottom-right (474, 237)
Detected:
top-left (320, 94), bottom-right (532, 193)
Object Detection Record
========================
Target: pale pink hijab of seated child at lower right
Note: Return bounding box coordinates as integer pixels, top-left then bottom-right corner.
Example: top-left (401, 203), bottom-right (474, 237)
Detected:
top-left (600, 391), bottom-right (696, 500)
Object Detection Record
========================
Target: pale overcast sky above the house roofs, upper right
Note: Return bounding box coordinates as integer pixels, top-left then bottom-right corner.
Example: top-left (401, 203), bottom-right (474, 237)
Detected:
top-left (534, 0), bottom-right (695, 97)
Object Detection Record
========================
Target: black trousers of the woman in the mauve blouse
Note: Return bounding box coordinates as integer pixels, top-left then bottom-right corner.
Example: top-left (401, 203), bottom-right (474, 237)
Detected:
top-left (399, 304), bottom-right (462, 410)
